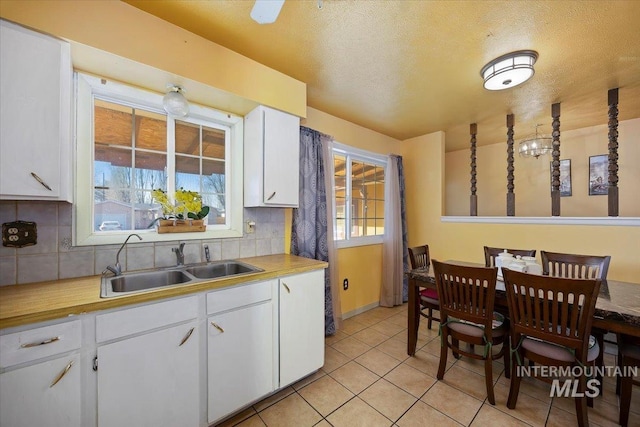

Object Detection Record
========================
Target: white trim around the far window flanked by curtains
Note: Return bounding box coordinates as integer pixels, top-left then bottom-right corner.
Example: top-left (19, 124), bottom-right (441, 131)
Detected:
top-left (331, 141), bottom-right (388, 249)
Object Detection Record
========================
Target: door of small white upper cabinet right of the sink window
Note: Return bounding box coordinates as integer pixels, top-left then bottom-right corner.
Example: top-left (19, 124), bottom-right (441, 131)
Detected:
top-left (263, 108), bottom-right (300, 207)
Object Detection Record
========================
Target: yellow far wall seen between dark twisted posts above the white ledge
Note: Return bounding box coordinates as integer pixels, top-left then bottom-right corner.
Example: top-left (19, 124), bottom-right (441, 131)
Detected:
top-left (445, 119), bottom-right (640, 217)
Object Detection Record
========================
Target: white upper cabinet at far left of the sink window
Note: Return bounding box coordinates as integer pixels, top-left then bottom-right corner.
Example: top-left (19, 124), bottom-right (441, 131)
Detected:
top-left (0, 20), bottom-right (72, 202)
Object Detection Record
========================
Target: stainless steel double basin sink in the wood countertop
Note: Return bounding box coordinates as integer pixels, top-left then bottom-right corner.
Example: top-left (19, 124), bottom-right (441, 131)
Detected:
top-left (100, 261), bottom-right (264, 298)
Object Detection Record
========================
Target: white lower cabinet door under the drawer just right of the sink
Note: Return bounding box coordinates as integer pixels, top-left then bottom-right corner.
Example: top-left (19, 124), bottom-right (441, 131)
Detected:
top-left (207, 301), bottom-right (274, 423)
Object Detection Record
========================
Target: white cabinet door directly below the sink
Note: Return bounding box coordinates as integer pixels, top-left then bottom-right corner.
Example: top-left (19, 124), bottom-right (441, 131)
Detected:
top-left (98, 321), bottom-right (200, 427)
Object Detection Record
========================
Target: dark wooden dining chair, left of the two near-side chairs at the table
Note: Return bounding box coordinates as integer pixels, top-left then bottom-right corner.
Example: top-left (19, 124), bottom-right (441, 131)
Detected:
top-left (433, 260), bottom-right (509, 405)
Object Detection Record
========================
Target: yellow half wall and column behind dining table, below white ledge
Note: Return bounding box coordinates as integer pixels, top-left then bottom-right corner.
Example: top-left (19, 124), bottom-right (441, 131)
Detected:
top-left (402, 133), bottom-right (640, 283)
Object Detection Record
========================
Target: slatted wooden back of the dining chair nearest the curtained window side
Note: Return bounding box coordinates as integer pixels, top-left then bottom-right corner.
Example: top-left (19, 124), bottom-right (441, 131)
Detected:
top-left (433, 260), bottom-right (498, 329)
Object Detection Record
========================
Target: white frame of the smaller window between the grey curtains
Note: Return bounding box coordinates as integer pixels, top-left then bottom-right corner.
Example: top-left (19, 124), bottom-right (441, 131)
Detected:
top-left (331, 141), bottom-right (388, 249)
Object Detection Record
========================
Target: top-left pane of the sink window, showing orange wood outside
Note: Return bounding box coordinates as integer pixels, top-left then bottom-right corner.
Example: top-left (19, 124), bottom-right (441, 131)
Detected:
top-left (93, 99), bottom-right (133, 148)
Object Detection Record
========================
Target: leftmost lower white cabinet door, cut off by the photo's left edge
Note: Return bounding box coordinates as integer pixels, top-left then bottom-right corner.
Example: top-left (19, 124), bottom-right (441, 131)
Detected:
top-left (0, 354), bottom-right (81, 427)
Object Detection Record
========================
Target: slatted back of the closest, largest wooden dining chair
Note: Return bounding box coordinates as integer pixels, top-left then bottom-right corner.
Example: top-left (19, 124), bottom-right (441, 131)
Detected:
top-left (503, 268), bottom-right (601, 354)
